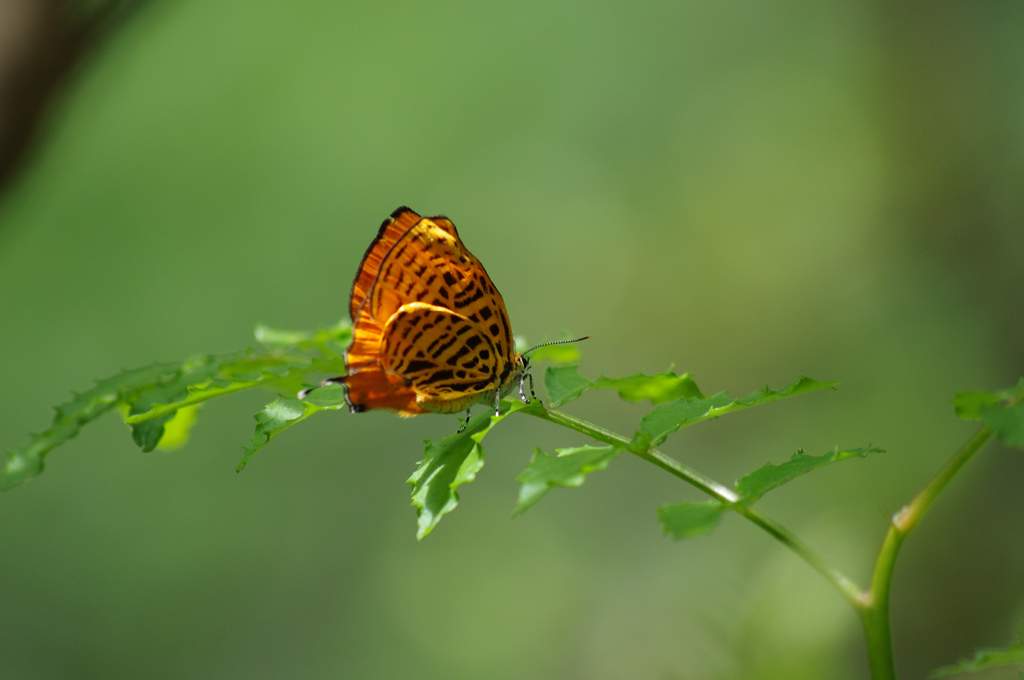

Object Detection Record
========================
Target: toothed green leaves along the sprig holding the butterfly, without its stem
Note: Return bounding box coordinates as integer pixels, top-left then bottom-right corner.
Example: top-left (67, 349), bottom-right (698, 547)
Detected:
top-left (0, 324), bottom-right (876, 553)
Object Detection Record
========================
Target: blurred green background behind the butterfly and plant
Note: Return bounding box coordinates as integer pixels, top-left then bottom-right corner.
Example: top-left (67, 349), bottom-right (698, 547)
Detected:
top-left (0, 0), bottom-right (1024, 680)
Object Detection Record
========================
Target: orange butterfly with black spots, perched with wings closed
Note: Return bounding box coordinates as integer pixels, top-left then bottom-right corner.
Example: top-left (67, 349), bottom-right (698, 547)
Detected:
top-left (300, 207), bottom-right (575, 419)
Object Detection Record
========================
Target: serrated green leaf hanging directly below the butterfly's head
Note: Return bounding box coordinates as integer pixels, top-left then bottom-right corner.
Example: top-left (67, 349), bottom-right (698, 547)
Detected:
top-left (407, 400), bottom-right (526, 540)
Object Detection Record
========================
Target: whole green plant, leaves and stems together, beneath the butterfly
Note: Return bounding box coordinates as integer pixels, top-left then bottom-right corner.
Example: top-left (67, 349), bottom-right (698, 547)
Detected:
top-left (0, 315), bottom-right (1024, 678)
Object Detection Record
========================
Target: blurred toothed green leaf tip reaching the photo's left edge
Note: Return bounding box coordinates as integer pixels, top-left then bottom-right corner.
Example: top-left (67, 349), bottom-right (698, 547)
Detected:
top-left (0, 364), bottom-right (177, 491)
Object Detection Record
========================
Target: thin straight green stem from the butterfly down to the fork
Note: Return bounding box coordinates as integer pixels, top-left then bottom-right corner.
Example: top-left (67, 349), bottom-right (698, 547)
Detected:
top-left (523, 401), bottom-right (863, 608)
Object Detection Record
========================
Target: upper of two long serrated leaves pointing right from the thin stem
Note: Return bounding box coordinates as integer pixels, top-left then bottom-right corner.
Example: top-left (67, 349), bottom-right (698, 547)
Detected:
top-left (636, 378), bottom-right (837, 445)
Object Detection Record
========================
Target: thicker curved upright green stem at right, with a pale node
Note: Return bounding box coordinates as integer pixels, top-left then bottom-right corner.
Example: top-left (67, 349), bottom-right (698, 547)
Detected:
top-left (858, 427), bottom-right (992, 680)
